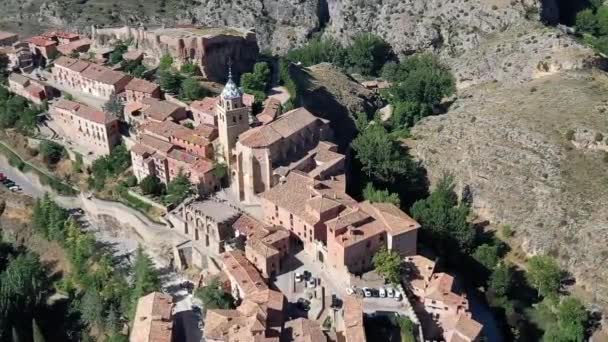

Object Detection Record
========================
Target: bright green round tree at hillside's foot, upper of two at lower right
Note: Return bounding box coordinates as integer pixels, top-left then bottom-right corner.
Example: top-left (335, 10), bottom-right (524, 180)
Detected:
top-left (526, 255), bottom-right (562, 297)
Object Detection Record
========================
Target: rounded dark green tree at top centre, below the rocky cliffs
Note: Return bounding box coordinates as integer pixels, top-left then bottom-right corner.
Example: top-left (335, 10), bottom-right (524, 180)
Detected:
top-left (346, 33), bottom-right (393, 76)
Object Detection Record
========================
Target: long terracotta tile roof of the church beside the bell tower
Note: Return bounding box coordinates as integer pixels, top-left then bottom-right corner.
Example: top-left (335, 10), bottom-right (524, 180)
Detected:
top-left (239, 108), bottom-right (319, 148)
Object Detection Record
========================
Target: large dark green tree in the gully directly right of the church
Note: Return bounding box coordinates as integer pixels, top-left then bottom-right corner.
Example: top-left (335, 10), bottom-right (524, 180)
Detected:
top-left (351, 124), bottom-right (414, 183)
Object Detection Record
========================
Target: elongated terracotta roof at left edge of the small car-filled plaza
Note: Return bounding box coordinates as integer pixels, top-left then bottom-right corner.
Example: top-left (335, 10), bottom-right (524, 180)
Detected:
top-left (222, 250), bottom-right (268, 298)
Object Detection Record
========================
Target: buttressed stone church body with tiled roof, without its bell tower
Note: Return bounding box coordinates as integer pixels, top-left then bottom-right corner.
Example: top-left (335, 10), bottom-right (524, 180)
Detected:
top-left (235, 108), bottom-right (334, 203)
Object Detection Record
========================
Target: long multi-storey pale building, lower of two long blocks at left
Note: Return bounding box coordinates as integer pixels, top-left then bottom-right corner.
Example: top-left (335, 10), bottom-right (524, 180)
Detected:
top-left (49, 99), bottom-right (121, 155)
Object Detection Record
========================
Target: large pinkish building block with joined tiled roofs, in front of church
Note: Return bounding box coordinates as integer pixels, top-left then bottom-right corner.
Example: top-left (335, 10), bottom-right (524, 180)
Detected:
top-left (260, 170), bottom-right (420, 274)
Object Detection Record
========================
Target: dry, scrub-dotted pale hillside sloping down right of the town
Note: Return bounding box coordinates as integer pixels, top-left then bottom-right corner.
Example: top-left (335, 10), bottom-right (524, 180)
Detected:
top-left (408, 72), bottom-right (608, 307)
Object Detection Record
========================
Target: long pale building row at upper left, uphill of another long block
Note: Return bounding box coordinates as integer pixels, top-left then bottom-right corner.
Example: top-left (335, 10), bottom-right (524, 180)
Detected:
top-left (53, 56), bottom-right (133, 99)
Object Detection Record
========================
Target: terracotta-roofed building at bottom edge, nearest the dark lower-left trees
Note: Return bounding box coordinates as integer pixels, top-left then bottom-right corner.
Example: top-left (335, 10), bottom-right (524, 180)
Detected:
top-left (130, 292), bottom-right (173, 342)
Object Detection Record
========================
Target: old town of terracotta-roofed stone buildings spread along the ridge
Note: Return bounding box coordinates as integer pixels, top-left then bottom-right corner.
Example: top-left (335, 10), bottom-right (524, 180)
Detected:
top-left (0, 27), bottom-right (490, 342)
